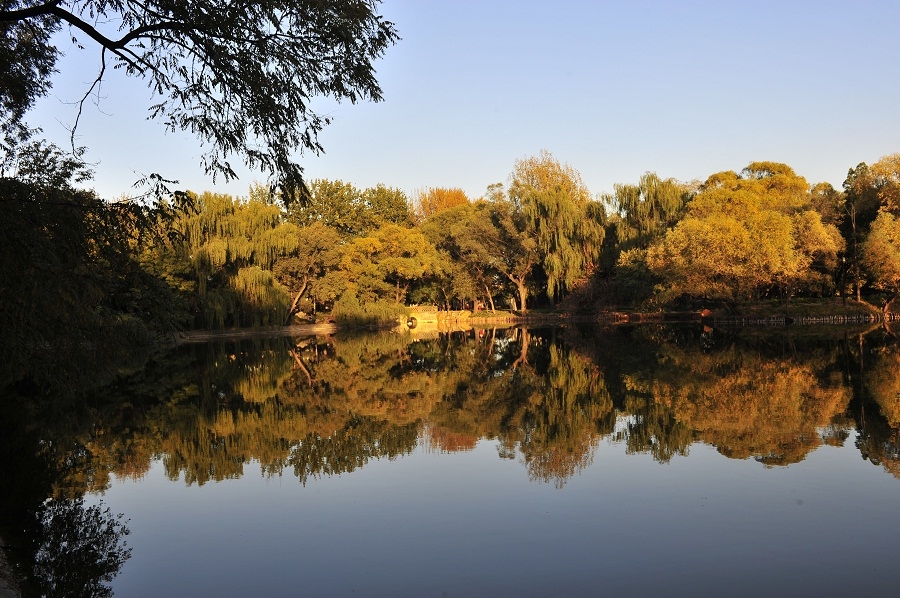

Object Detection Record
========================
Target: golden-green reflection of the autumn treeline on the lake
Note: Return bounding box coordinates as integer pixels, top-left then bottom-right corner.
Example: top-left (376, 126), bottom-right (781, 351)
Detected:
top-left (38, 326), bottom-right (900, 496)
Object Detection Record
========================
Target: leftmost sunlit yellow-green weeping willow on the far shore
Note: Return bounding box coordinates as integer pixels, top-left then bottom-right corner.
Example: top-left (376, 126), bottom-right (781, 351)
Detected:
top-left (168, 187), bottom-right (297, 328)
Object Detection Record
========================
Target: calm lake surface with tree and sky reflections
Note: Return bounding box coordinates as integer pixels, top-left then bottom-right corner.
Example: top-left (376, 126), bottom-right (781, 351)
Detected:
top-left (4, 325), bottom-right (900, 597)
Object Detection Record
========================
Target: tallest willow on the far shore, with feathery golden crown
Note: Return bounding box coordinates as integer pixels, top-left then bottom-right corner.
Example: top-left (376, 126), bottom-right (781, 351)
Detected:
top-left (509, 151), bottom-right (605, 299)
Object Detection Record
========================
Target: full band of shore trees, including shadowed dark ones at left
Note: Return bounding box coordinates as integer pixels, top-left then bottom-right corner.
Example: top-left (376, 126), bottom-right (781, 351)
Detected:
top-left (0, 142), bottom-right (900, 394)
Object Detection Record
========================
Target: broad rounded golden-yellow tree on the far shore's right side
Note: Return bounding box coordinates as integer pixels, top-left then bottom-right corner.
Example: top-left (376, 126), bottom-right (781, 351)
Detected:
top-left (647, 162), bottom-right (843, 301)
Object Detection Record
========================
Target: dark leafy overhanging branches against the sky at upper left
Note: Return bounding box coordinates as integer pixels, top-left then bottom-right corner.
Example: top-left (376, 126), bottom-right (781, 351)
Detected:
top-left (0, 0), bottom-right (398, 187)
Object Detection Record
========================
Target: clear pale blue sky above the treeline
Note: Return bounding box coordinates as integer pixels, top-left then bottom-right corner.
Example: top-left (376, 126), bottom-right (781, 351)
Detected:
top-left (24, 0), bottom-right (900, 203)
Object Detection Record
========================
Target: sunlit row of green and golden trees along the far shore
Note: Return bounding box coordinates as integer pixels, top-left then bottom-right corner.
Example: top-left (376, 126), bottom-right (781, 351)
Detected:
top-left (125, 152), bottom-right (900, 327)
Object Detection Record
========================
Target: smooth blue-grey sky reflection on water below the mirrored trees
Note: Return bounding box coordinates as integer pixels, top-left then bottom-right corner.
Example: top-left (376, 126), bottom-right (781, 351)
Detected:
top-left (89, 436), bottom-right (900, 596)
